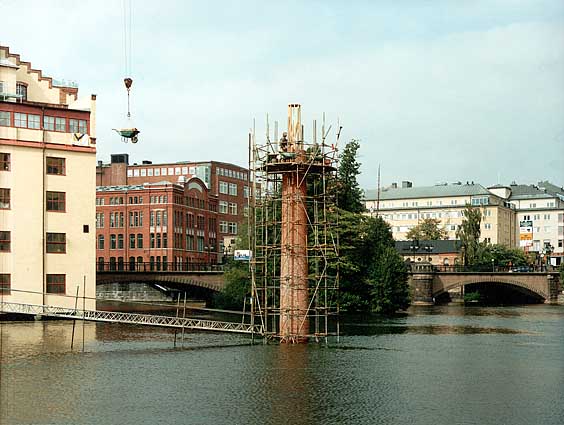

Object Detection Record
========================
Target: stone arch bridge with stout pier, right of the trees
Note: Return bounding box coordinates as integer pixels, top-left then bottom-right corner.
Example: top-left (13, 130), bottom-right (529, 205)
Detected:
top-left (409, 263), bottom-right (561, 305)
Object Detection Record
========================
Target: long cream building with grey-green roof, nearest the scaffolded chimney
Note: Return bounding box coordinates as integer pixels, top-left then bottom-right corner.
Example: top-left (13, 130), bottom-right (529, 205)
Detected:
top-left (365, 181), bottom-right (517, 247)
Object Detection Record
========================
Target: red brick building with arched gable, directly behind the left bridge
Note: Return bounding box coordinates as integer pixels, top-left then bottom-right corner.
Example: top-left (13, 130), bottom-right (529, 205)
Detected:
top-left (96, 177), bottom-right (220, 270)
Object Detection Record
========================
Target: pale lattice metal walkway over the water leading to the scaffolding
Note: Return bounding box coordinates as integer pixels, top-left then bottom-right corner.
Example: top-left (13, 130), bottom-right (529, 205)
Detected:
top-left (0, 302), bottom-right (263, 335)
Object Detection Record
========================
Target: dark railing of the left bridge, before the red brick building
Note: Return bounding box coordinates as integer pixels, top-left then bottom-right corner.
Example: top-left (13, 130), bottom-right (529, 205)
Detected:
top-left (96, 261), bottom-right (223, 273)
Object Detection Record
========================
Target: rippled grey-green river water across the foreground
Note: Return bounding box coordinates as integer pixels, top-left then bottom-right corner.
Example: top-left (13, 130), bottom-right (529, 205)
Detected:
top-left (0, 305), bottom-right (564, 425)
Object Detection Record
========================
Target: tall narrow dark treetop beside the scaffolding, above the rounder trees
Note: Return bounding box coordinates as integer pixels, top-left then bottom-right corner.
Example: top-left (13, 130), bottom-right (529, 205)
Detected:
top-left (337, 139), bottom-right (364, 213)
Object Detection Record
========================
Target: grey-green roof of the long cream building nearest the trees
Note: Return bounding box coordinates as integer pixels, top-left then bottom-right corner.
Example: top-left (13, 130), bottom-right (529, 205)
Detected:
top-left (365, 183), bottom-right (492, 201)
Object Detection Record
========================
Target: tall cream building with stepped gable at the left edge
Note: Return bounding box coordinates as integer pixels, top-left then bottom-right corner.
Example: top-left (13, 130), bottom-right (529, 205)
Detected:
top-left (0, 46), bottom-right (96, 308)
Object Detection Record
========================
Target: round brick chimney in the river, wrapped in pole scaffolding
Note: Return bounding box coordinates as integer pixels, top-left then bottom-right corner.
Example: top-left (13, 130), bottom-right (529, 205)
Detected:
top-left (249, 104), bottom-right (339, 343)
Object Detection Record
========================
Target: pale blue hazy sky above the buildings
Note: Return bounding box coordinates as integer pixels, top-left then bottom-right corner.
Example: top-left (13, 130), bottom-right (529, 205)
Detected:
top-left (0, 0), bottom-right (564, 189)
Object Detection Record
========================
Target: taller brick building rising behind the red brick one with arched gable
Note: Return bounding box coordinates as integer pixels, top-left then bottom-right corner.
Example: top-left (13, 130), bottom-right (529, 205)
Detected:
top-left (96, 154), bottom-right (250, 252)
